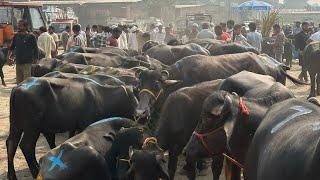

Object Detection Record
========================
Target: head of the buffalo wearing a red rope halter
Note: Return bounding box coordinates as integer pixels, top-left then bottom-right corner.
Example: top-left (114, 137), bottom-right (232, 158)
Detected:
top-left (185, 91), bottom-right (240, 161)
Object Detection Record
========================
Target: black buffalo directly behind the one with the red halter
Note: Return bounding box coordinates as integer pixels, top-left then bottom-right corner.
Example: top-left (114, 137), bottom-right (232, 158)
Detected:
top-left (156, 72), bottom-right (290, 179)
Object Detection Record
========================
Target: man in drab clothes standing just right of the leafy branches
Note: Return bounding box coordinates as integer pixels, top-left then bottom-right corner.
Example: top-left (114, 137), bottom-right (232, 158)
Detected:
top-left (272, 24), bottom-right (285, 63)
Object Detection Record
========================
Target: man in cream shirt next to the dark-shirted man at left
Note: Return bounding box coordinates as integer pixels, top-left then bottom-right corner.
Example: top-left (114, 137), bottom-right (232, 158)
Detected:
top-left (37, 27), bottom-right (56, 58)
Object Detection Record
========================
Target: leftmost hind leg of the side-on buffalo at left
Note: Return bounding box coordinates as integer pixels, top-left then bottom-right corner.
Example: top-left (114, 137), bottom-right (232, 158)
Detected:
top-left (6, 125), bottom-right (22, 180)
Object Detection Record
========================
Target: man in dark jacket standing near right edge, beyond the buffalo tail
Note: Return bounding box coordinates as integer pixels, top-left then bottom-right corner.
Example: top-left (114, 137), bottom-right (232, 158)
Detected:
top-left (295, 22), bottom-right (310, 81)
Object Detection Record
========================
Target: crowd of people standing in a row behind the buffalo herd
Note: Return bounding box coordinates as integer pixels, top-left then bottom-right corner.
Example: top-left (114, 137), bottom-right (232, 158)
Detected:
top-left (8, 20), bottom-right (320, 83)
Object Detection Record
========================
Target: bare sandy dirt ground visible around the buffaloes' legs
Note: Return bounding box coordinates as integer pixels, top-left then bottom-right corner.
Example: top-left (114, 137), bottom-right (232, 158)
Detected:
top-left (0, 62), bottom-right (309, 180)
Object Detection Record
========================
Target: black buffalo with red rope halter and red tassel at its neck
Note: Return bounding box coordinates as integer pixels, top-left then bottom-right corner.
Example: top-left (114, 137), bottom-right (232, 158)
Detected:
top-left (185, 82), bottom-right (294, 179)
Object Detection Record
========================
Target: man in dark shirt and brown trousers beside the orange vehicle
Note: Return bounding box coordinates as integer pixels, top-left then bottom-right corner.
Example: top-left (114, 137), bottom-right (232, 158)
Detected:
top-left (8, 20), bottom-right (38, 84)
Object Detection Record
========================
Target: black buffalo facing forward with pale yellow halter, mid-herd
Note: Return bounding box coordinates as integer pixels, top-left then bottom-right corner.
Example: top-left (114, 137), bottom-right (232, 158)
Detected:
top-left (136, 53), bottom-right (304, 118)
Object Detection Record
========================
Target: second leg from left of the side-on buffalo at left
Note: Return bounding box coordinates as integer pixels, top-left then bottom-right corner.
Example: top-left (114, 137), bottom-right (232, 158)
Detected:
top-left (20, 131), bottom-right (40, 178)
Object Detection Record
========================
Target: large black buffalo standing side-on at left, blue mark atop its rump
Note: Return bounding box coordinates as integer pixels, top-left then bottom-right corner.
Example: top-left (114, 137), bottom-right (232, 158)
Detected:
top-left (6, 77), bottom-right (137, 179)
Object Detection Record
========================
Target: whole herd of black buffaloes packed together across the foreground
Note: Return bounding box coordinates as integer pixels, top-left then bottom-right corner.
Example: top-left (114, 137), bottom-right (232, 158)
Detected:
top-left (0, 40), bottom-right (320, 180)
